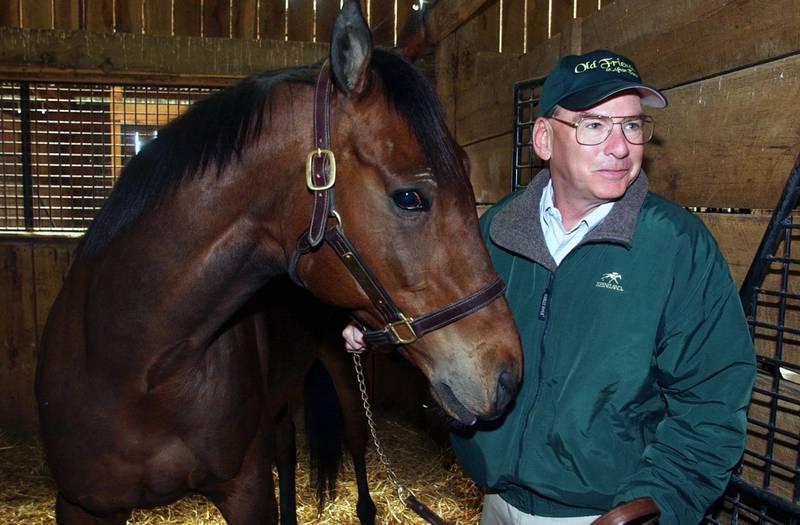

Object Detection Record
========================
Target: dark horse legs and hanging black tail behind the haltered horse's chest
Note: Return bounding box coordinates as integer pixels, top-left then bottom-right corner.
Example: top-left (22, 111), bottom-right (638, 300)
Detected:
top-left (254, 278), bottom-right (376, 525)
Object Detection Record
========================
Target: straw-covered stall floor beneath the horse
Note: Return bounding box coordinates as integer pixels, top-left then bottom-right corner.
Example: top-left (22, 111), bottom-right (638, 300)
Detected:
top-left (0, 419), bottom-right (481, 525)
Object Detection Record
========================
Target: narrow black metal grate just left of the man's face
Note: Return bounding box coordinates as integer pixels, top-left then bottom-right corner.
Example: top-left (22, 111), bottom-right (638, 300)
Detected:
top-left (511, 77), bottom-right (545, 191)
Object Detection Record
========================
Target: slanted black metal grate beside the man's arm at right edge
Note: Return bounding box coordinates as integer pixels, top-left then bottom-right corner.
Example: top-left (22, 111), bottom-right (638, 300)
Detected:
top-left (725, 157), bottom-right (800, 525)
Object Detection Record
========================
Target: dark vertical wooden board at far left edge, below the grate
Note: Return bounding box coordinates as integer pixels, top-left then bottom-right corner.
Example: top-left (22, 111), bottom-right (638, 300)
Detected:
top-left (0, 243), bottom-right (36, 426)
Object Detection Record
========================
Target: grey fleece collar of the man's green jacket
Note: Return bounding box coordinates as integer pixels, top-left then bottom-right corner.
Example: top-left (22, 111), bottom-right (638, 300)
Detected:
top-left (489, 169), bottom-right (648, 270)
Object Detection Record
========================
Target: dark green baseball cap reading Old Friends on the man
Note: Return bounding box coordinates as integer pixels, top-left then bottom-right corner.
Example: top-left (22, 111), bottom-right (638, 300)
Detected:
top-left (539, 49), bottom-right (667, 117)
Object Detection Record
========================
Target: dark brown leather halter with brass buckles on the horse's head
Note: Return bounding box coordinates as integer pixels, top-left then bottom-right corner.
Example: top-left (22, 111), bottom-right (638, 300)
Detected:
top-left (289, 61), bottom-right (505, 346)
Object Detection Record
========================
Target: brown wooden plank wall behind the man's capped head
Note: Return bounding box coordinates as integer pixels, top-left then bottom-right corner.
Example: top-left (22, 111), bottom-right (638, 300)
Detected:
top-left (436, 0), bottom-right (800, 288)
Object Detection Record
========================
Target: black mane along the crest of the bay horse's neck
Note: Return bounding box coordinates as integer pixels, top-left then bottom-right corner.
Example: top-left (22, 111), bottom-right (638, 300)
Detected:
top-left (78, 66), bottom-right (318, 256)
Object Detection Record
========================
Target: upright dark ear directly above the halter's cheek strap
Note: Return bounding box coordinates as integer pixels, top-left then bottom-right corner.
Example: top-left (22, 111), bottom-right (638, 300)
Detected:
top-left (330, 0), bottom-right (372, 97)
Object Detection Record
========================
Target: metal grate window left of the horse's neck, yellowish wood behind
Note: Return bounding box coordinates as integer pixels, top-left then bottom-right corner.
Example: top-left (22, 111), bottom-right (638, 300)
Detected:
top-left (0, 82), bottom-right (213, 233)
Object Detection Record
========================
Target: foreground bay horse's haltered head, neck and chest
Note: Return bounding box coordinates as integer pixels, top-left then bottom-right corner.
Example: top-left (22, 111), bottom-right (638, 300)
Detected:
top-left (36, 0), bottom-right (522, 525)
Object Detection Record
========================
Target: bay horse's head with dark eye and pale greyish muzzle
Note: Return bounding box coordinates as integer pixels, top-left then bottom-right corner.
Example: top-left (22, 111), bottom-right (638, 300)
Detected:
top-left (284, 1), bottom-right (522, 424)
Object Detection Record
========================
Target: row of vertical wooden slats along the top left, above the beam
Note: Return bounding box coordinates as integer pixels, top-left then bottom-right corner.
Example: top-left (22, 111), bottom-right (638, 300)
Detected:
top-left (0, 0), bottom-right (417, 45)
